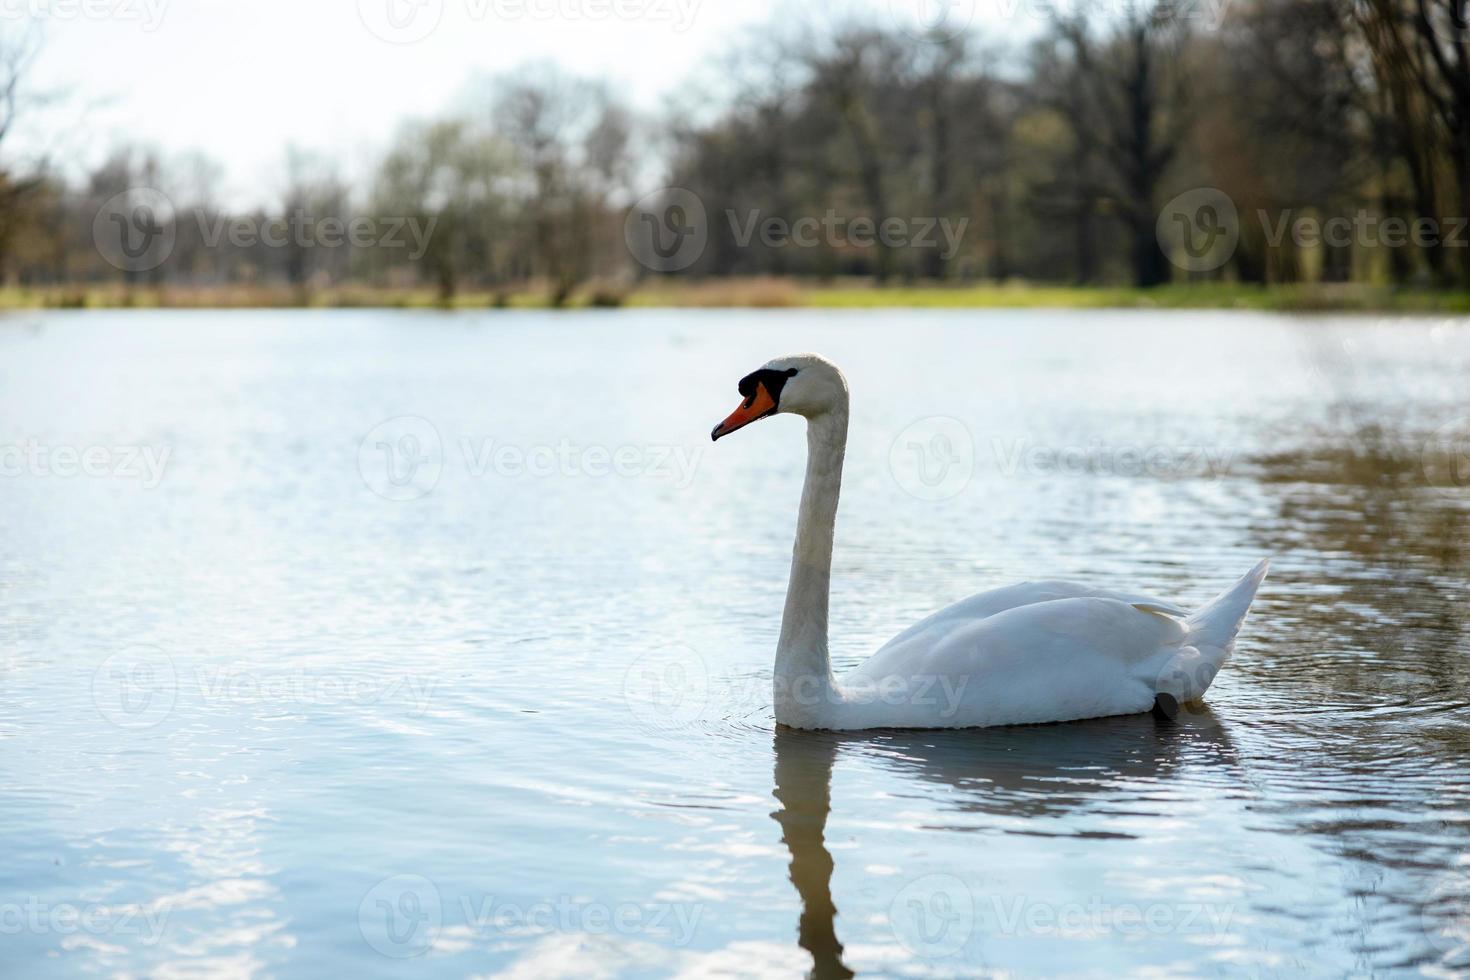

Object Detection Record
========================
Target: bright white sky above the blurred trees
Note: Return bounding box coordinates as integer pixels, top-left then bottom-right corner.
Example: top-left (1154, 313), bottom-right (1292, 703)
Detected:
top-left (11, 0), bottom-right (1026, 206)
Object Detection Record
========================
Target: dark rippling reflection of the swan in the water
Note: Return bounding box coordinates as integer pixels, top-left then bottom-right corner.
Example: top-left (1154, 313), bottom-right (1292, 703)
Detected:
top-left (772, 705), bottom-right (1236, 980)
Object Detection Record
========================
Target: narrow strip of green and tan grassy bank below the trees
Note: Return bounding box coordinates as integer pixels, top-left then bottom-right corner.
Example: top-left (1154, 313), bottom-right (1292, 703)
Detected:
top-left (0, 279), bottom-right (1470, 313)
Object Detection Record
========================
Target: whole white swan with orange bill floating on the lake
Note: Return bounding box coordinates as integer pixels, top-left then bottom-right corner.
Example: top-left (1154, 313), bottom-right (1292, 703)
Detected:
top-left (710, 354), bottom-right (1267, 730)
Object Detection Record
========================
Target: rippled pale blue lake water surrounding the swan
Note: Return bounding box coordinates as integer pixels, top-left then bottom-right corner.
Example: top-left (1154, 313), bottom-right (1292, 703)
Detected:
top-left (0, 311), bottom-right (1470, 977)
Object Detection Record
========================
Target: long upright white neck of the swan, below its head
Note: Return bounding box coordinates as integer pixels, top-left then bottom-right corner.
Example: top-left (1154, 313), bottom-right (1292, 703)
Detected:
top-left (775, 404), bottom-right (847, 727)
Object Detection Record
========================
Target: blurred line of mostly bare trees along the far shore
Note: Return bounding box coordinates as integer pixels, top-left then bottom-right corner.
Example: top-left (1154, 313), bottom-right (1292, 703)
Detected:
top-left (0, 0), bottom-right (1470, 303)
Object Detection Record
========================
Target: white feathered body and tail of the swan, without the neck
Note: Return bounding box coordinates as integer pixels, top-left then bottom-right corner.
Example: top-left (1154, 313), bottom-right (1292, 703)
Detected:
top-left (829, 561), bottom-right (1269, 729)
